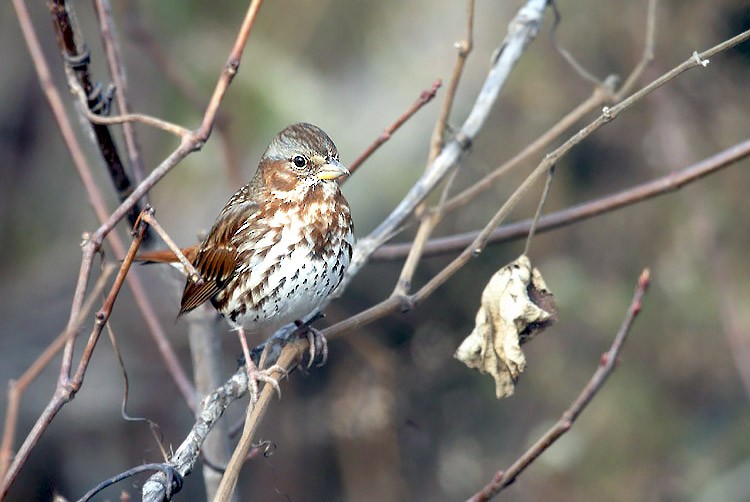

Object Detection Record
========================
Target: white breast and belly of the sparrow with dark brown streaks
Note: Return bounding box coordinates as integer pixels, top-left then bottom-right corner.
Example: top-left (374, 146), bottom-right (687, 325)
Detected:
top-left (217, 183), bottom-right (354, 332)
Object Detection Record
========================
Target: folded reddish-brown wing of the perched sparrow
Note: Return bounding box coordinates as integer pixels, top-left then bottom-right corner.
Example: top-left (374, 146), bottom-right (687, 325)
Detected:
top-left (178, 197), bottom-right (258, 315)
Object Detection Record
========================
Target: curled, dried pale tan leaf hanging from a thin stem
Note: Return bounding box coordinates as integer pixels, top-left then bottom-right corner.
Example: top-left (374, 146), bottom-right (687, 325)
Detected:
top-left (454, 255), bottom-right (557, 399)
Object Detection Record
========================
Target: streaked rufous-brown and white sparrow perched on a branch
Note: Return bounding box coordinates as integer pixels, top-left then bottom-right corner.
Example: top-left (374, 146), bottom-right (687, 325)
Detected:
top-left (137, 123), bottom-right (354, 400)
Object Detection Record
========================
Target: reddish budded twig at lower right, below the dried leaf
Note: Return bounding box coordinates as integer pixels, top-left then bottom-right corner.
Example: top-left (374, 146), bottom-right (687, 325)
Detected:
top-left (467, 269), bottom-right (650, 502)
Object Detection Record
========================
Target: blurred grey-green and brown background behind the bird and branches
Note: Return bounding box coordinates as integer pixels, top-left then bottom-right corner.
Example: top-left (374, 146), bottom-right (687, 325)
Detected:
top-left (0, 0), bottom-right (750, 501)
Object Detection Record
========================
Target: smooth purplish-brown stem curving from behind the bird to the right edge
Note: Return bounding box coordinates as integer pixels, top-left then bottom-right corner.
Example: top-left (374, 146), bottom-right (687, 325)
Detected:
top-left (372, 140), bottom-right (750, 261)
